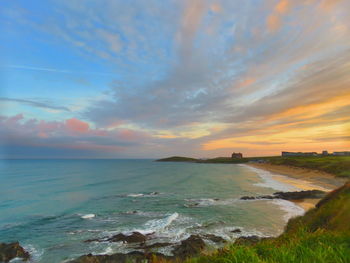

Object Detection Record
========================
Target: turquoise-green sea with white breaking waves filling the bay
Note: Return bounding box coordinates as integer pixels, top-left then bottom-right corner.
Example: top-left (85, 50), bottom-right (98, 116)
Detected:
top-left (0, 160), bottom-right (303, 263)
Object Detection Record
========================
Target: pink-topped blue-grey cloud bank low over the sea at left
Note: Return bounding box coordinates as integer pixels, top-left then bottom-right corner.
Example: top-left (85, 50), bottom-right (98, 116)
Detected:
top-left (0, 114), bottom-right (151, 157)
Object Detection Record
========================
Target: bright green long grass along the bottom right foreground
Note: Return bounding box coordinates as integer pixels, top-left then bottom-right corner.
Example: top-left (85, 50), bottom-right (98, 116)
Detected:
top-left (185, 231), bottom-right (350, 263)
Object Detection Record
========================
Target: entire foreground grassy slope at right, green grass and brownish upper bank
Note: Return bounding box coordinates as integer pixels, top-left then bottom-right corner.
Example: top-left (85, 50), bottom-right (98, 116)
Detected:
top-left (180, 183), bottom-right (350, 263)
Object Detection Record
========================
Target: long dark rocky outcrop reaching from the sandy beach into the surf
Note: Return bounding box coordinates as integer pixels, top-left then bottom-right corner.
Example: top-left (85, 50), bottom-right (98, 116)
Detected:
top-left (240, 190), bottom-right (326, 200)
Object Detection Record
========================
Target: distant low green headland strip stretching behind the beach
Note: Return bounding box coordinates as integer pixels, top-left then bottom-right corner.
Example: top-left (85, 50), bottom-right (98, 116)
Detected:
top-left (158, 156), bottom-right (350, 178)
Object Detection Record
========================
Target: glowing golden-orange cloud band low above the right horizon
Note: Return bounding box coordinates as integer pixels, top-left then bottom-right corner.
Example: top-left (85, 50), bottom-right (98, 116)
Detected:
top-left (202, 93), bottom-right (350, 155)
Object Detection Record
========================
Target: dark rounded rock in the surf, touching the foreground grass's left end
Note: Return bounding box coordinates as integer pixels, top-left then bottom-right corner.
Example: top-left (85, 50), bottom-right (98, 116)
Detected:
top-left (172, 235), bottom-right (205, 259)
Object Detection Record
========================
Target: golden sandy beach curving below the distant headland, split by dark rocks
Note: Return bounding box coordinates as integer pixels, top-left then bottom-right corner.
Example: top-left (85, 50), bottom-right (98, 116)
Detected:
top-left (248, 163), bottom-right (347, 211)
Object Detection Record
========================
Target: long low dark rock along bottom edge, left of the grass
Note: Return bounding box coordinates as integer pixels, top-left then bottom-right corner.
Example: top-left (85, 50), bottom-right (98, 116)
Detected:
top-left (68, 251), bottom-right (172, 263)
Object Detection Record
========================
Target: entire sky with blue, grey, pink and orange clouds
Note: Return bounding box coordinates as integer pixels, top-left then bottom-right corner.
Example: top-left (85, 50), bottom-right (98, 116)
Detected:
top-left (0, 0), bottom-right (350, 158)
